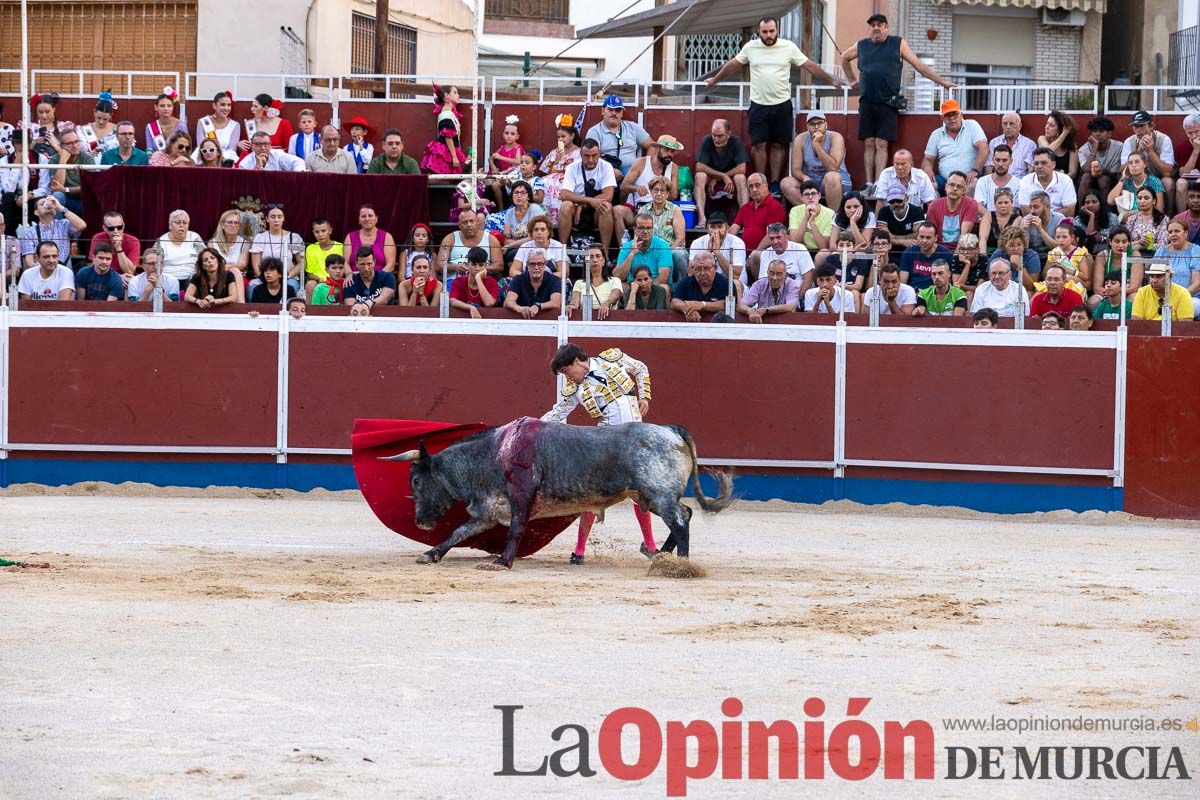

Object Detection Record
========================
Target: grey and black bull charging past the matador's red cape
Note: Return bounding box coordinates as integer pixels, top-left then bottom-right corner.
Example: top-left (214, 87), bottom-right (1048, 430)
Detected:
top-left (384, 417), bottom-right (733, 570)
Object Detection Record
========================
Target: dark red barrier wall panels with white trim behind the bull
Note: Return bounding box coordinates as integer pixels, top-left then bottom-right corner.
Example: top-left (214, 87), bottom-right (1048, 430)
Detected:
top-left (8, 309), bottom-right (1200, 518)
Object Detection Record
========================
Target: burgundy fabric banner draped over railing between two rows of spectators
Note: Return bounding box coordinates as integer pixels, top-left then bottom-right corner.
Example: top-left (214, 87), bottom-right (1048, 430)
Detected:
top-left (82, 167), bottom-right (430, 250)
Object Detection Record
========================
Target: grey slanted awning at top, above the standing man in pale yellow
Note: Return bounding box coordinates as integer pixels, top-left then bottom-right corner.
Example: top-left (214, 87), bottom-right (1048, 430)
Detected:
top-left (575, 0), bottom-right (801, 38)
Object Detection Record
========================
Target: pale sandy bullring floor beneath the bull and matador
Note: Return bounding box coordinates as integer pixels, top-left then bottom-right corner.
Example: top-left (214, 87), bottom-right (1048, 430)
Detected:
top-left (0, 487), bottom-right (1200, 800)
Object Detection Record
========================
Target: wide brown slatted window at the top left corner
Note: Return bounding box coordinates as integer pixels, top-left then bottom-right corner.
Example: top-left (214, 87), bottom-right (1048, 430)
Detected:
top-left (0, 0), bottom-right (196, 96)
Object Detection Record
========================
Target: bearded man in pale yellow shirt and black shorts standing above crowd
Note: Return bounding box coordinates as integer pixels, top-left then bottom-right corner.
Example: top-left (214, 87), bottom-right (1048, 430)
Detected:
top-left (706, 17), bottom-right (850, 194)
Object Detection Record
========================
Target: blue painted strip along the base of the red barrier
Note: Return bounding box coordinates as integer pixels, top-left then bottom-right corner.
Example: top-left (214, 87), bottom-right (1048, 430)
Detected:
top-left (0, 453), bottom-right (1123, 513)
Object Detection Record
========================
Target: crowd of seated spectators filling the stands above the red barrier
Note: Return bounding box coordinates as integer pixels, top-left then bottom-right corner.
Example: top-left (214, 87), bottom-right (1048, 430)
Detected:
top-left (0, 68), bottom-right (1200, 323)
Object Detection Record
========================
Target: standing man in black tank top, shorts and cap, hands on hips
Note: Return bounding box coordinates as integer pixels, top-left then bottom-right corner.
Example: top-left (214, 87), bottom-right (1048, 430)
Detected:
top-left (841, 14), bottom-right (956, 188)
